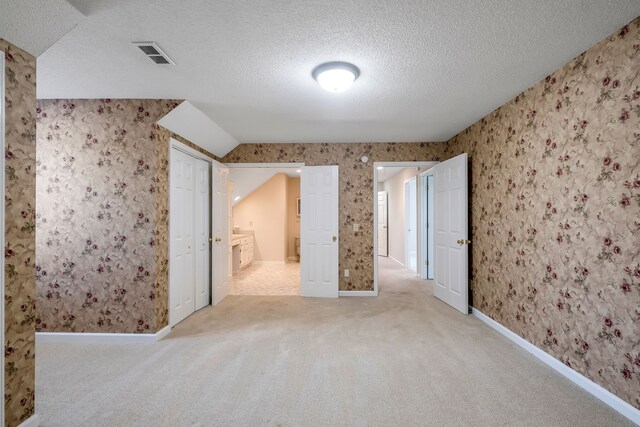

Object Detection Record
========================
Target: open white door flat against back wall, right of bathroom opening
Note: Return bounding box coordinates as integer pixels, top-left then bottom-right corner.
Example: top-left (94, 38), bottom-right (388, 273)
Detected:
top-left (300, 166), bottom-right (339, 298)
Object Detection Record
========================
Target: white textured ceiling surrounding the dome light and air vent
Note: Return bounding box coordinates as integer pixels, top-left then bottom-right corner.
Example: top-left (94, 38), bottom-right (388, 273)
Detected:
top-left (22, 0), bottom-right (640, 142)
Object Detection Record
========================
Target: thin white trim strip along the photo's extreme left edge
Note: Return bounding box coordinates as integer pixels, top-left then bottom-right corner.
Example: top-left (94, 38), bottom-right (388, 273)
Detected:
top-left (0, 50), bottom-right (6, 425)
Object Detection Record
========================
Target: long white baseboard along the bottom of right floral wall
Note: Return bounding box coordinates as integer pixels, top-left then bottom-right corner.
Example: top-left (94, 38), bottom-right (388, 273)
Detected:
top-left (471, 307), bottom-right (640, 425)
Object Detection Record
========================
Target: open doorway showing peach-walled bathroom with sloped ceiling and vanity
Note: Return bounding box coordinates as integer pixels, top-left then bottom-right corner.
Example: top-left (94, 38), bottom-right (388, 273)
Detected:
top-left (229, 165), bottom-right (302, 296)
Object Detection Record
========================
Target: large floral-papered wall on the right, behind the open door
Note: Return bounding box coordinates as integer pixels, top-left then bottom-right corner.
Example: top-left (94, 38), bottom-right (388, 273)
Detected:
top-left (447, 18), bottom-right (640, 408)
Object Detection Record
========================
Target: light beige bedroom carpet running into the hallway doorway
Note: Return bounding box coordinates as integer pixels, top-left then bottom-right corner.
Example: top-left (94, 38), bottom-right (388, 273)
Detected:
top-left (36, 259), bottom-right (630, 427)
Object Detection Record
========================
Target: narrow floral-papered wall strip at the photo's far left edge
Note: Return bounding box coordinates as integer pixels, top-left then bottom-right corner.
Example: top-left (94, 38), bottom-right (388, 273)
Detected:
top-left (0, 39), bottom-right (36, 426)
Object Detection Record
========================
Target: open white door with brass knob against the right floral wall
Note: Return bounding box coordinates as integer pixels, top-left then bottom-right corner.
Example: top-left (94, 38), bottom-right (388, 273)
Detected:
top-left (433, 153), bottom-right (471, 314)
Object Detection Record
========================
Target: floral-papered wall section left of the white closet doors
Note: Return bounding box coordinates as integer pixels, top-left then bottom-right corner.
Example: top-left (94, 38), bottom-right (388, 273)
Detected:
top-left (35, 99), bottom-right (188, 333)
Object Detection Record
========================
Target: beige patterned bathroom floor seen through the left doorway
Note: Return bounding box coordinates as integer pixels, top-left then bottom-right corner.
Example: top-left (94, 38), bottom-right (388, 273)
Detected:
top-left (229, 262), bottom-right (300, 296)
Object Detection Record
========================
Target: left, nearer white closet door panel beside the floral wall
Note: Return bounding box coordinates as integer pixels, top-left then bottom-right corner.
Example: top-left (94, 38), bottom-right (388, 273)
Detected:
top-left (169, 149), bottom-right (196, 326)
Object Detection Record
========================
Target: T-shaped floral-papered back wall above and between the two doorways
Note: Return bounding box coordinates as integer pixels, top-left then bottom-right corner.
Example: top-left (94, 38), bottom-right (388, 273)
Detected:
top-left (222, 143), bottom-right (446, 291)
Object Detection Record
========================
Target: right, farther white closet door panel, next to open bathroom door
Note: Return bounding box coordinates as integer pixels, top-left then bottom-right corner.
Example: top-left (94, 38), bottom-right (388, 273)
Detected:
top-left (195, 160), bottom-right (211, 310)
